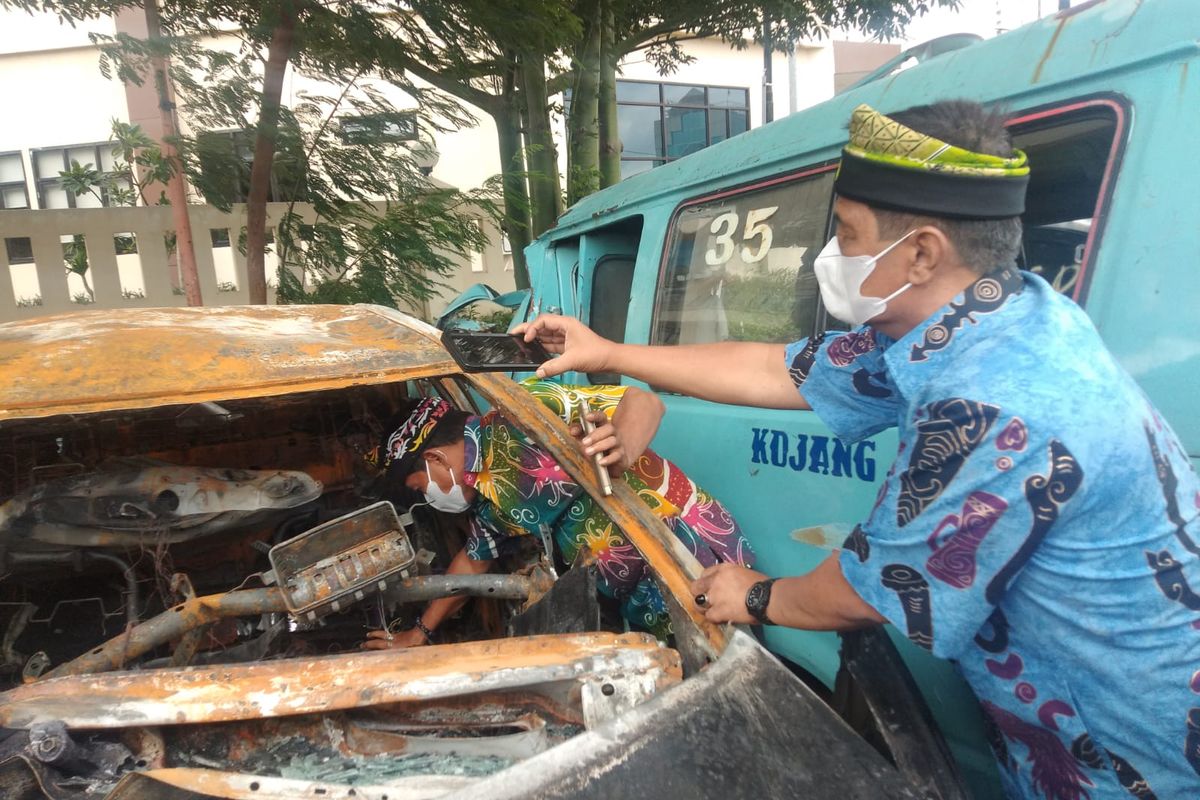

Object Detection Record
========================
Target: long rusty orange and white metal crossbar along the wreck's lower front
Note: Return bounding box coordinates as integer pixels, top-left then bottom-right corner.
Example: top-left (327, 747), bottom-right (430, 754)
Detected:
top-left (0, 632), bottom-right (683, 728)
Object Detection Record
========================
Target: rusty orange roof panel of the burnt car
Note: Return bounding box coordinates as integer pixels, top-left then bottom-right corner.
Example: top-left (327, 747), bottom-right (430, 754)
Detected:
top-left (0, 306), bottom-right (458, 420)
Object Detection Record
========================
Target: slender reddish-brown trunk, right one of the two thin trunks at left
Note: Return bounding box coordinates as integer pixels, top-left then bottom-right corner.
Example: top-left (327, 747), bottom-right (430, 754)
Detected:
top-left (246, 0), bottom-right (296, 305)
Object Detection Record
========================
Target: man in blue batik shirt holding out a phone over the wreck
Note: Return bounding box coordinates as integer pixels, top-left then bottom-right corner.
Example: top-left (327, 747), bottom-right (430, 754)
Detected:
top-left (523, 102), bottom-right (1200, 800)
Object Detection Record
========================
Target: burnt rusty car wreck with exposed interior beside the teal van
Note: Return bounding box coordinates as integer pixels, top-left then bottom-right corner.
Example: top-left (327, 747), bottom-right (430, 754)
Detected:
top-left (0, 306), bottom-right (928, 800)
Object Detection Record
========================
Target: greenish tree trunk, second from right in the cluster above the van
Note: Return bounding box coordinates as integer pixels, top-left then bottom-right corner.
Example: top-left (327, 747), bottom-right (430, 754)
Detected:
top-left (566, 0), bottom-right (601, 205)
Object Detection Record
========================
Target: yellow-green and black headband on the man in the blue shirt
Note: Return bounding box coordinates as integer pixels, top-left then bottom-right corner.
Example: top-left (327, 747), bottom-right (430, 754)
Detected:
top-left (834, 104), bottom-right (1030, 219)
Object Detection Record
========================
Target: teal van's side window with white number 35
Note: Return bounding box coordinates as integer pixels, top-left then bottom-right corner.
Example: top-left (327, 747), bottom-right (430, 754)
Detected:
top-left (650, 167), bottom-right (834, 344)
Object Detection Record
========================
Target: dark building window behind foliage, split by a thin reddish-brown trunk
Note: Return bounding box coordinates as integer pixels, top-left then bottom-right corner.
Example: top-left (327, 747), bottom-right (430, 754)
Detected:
top-left (193, 126), bottom-right (307, 209)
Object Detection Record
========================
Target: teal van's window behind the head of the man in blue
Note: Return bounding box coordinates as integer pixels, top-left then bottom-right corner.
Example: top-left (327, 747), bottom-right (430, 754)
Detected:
top-left (1012, 102), bottom-right (1120, 302)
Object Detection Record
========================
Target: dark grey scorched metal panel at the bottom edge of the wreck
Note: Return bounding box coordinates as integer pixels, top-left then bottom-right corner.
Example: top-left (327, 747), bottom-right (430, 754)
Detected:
top-left (446, 631), bottom-right (926, 800)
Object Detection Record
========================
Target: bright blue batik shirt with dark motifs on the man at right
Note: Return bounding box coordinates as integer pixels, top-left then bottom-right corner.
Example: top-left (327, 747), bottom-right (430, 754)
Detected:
top-left (787, 270), bottom-right (1200, 800)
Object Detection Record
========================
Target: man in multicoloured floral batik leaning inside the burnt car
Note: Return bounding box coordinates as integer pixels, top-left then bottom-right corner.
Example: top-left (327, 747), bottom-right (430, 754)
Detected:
top-left (365, 380), bottom-right (754, 649)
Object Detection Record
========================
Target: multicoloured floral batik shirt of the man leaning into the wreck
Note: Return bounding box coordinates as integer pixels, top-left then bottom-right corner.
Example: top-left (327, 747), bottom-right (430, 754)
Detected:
top-left (463, 380), bottom-right (754, 637)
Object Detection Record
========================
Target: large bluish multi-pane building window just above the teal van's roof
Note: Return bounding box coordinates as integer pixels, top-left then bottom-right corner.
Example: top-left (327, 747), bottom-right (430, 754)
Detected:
top-left (617, 80), bottom-right (750, 179)
